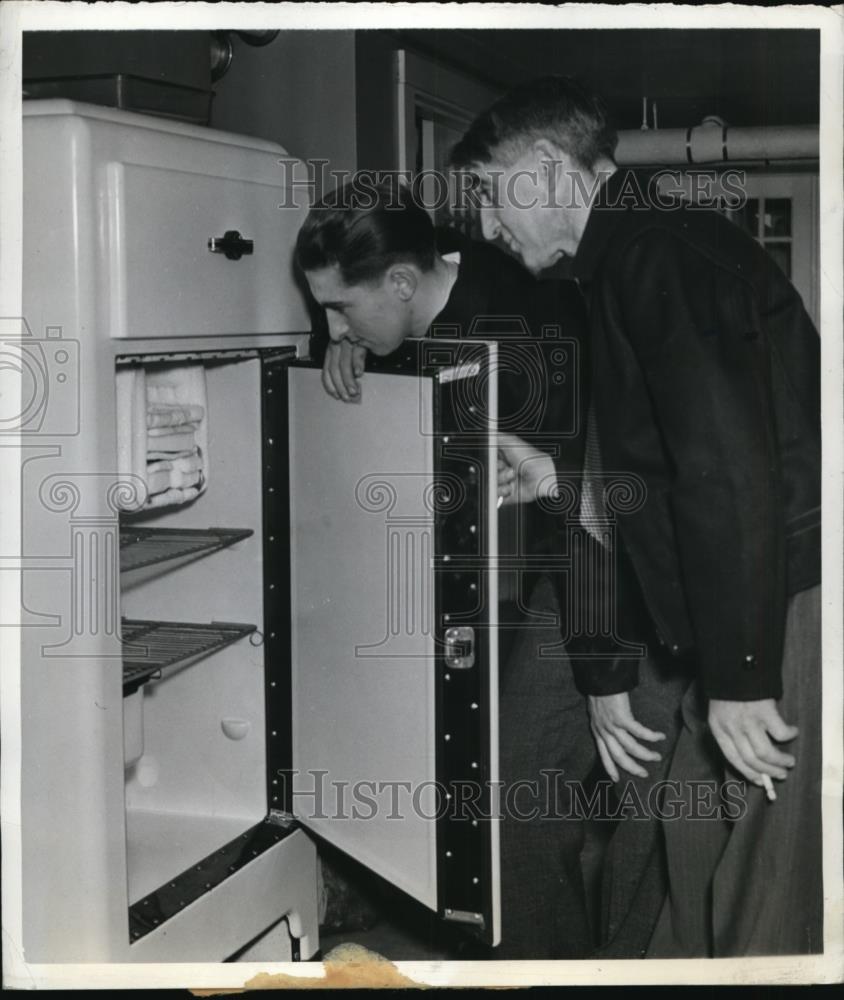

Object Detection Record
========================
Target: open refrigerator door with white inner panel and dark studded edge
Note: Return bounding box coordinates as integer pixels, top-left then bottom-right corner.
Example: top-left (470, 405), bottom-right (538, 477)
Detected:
top-left (288, 340), bottom-right (500, 943)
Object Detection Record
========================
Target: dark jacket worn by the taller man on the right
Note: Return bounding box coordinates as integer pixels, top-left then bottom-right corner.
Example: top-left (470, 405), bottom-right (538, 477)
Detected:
top-left (573, 170), bottom-right (820, 701)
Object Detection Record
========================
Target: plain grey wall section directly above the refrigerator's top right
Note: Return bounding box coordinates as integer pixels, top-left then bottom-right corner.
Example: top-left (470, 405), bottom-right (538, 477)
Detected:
top-left (211, 31), bottom-right (357, 179)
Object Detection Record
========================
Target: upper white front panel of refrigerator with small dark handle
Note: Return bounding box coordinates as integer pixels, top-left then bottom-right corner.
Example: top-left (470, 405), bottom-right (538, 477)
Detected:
top-left (101, 163), bottom-right (310, 337)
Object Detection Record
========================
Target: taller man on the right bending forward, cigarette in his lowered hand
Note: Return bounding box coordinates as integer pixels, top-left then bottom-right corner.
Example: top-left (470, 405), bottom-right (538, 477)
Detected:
top-left (453, 77), bottom-right (823, 956)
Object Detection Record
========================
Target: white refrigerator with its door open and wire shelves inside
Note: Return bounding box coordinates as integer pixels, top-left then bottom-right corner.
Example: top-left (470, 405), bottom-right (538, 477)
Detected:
top-left (16, 100), bottom-right (500, 962)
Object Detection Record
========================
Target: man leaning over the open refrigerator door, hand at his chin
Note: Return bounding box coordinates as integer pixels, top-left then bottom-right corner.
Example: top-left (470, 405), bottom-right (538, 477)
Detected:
top-left (296, 180), bottom-right (620, 958)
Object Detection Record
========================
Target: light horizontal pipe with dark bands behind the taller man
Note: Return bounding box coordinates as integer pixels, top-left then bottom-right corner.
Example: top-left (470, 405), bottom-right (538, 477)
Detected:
top-left (615, 122), bottom-right (819, 166)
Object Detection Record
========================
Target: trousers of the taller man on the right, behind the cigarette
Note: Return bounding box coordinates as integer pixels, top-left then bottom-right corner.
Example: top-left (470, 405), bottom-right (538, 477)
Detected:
top-left (648, 587), bottom-right (823, 958)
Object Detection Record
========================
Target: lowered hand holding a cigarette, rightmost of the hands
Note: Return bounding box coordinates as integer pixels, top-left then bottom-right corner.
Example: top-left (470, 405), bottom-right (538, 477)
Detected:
top-left (709, 698), bottom-right (797, 785)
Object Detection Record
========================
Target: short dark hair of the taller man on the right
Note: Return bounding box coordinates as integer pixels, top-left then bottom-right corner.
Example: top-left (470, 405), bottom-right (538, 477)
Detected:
top-left (451, 76), bottom-right (618, 170)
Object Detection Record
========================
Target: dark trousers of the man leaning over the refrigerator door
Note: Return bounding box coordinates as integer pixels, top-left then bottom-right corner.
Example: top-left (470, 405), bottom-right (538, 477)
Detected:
top-left (494, 579), bottom-right (689, 959)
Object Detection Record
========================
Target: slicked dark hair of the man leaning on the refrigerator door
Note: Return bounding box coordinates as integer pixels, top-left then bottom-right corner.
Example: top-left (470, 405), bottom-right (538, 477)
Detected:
top-left (296, 175), bottom-right (436, 285)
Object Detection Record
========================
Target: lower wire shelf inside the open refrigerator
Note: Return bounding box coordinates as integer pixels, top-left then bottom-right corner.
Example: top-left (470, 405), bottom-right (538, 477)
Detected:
top-left (122, 618), bottom-right (257, 695)
